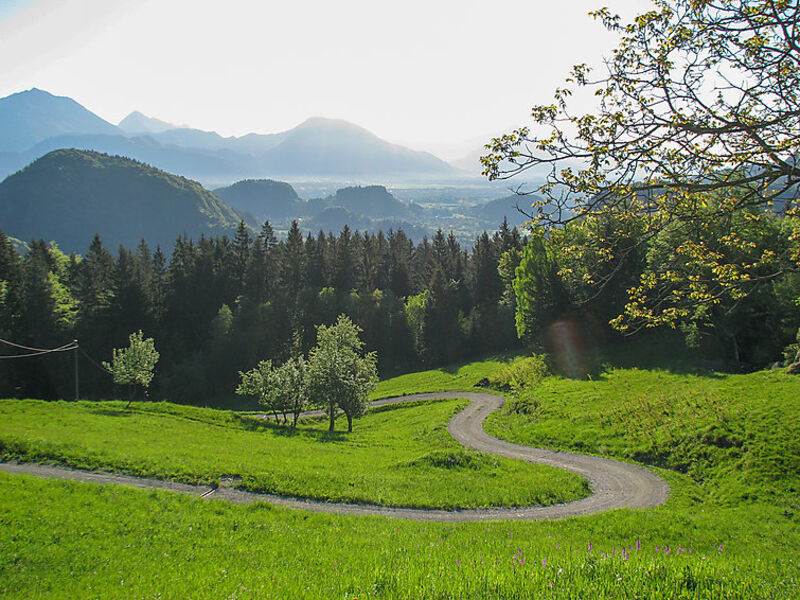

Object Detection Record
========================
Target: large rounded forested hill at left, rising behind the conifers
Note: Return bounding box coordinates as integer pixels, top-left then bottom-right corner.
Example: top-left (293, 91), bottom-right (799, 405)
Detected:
top-left (0, 150), bottom-right (240, 252)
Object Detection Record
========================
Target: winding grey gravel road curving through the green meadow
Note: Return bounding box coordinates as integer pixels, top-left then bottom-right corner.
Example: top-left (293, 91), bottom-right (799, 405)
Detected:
top-left (0, 392), bottom-right (669, 522)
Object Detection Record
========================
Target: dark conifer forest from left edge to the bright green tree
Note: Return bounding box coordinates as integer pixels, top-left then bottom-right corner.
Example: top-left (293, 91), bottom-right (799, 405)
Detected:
top-left (0, 222), bottom-right (526, 406)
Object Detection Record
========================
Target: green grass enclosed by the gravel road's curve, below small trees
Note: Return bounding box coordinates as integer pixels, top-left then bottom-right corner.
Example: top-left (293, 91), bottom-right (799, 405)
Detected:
top-left (0, 400), bottom-right (588, 508)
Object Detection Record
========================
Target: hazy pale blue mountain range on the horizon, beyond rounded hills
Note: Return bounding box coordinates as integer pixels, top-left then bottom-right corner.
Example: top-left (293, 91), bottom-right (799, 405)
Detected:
top-left (0, 88), bottom-right (459, 180)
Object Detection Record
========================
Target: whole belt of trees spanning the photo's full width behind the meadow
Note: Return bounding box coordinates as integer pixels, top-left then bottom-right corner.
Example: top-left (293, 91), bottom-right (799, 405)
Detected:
top-left (0, 196), bottom-right (800, 407)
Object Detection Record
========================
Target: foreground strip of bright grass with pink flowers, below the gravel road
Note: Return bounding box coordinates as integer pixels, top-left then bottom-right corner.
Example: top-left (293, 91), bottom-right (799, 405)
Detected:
top-left (0, 474), bottom-right (800, 600)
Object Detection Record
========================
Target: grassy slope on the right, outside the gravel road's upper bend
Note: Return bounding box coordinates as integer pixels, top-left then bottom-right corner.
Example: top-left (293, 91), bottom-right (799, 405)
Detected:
top-left (485, 368), bottom-right (800, 516)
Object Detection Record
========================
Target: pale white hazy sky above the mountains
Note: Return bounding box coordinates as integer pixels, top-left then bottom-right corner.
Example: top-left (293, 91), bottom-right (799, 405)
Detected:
top-left (0, 0), bottom-right (650, 157)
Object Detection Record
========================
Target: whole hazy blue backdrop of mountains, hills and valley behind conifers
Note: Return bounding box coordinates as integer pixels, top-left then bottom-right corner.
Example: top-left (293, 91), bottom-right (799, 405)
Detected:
top-left (0, 88), bottom-right (536, 252)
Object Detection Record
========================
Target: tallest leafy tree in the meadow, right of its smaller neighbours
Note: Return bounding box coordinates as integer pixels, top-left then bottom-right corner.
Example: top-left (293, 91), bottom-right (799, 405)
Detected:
top-left (308, 315), bottom-right (378, 431)
